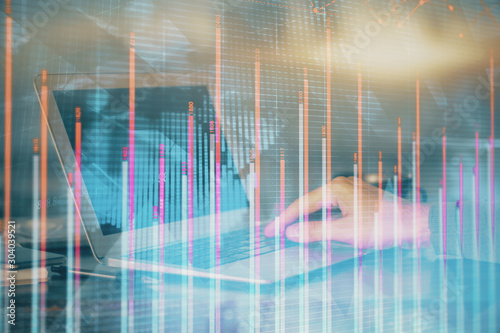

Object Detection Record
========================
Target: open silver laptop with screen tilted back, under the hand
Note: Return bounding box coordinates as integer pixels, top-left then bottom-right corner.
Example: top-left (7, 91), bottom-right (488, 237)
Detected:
top-left (34, 73), bottom-right (364, 284)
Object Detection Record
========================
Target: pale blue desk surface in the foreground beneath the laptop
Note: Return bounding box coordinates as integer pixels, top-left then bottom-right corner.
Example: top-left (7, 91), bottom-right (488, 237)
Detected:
top-left (8, 245), bottom-right (500, 332)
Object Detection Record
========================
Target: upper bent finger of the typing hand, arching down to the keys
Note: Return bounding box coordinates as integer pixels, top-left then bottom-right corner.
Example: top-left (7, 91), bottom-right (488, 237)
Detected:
top-left (264, 177), bottom-right (352, 237)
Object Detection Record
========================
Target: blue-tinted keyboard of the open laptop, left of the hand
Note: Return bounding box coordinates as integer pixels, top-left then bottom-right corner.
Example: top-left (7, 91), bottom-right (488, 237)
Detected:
top-left (134, 229), bottom-right (298, 269)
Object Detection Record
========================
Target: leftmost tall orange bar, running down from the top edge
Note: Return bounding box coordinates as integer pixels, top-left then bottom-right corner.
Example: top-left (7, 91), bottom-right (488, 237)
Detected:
top-left (4, 0), bottom-right (12, 228)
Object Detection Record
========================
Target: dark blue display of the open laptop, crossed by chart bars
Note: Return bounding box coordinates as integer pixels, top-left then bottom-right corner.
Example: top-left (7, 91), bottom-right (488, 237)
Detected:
top-left (53, 86), bottom-right (248, 235)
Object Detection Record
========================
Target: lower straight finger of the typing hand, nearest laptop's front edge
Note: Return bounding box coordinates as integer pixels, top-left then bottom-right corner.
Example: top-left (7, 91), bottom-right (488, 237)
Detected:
top-left (286, 217), bottom-right (354, 244)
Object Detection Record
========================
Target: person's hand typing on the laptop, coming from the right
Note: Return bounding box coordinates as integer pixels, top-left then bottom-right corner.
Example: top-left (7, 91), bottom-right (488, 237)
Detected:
top-left (264, 177), bottom-right (430, 248)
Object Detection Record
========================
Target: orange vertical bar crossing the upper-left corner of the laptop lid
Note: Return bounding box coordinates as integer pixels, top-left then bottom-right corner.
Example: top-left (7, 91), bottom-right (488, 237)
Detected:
top-left (40, 69), bottom-right (49, 327)
